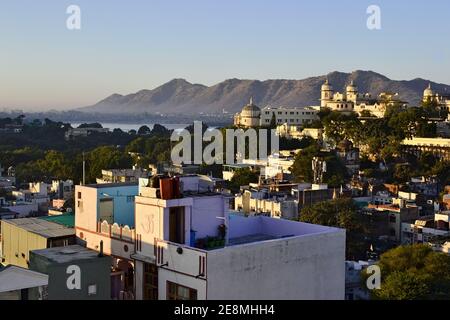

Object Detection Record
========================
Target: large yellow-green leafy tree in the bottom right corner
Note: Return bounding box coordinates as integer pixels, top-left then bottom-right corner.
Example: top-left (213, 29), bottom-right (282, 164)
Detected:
top-left (372, 245), bottom-right (450, 300)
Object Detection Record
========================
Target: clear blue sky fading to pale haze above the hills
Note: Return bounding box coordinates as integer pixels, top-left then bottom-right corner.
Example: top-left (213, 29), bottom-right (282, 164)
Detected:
top-left (0, 0), bottom-right (450, 110)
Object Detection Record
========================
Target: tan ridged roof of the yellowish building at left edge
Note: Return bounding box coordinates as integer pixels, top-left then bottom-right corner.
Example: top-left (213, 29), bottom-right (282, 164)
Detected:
top-left (3, 218), bottom-right (75, 238)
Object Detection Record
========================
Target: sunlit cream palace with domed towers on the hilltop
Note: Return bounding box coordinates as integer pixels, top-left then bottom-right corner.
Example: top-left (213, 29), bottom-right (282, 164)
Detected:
top-left (234, 79), bottom-right (450, 128)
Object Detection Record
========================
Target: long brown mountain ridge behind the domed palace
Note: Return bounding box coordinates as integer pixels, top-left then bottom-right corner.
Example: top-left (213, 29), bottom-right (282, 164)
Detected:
top-left (77, 71), bottom-right (450, 115)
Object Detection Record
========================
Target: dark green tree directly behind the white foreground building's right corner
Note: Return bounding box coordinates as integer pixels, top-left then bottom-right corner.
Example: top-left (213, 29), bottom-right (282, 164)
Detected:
top-left (300, 199), bottom-right (368, 259)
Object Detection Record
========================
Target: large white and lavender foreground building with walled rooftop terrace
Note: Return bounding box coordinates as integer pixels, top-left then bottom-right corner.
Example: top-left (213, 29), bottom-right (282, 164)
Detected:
top-left (76, 176), bottom-right (345, 300)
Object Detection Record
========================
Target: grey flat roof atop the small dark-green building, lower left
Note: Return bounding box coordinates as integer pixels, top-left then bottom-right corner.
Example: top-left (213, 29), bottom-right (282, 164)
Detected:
top-left (32, 245), bottom-right (106, 263)
